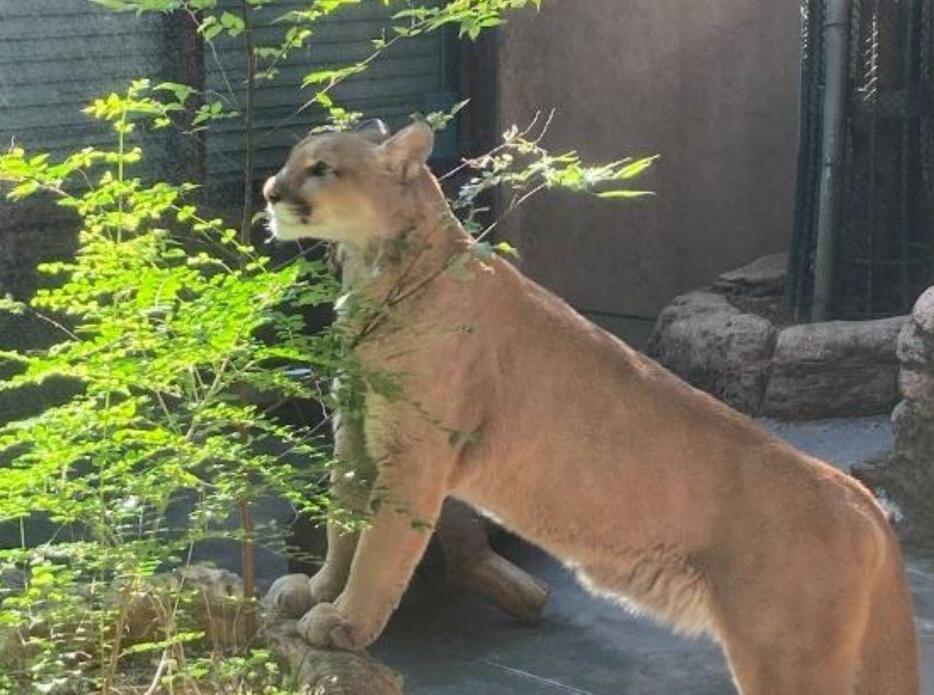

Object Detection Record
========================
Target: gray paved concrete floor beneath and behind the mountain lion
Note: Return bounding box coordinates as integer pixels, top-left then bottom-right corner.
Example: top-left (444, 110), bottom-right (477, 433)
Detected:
top-left (373, 418), bottom-right (934, 695)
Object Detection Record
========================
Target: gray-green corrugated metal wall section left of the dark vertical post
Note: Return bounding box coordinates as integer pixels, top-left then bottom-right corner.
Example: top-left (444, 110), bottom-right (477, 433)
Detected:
top-left (0, 0), bottom-right (174, 304)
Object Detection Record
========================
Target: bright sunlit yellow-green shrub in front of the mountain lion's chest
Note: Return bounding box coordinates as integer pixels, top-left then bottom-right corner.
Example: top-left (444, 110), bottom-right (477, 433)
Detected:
top-left (0, 80), bottom-right (341, 692)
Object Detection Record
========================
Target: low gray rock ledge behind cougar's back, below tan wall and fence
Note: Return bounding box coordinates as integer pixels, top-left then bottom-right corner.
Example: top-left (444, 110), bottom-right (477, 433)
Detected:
top-left (648, 254), bottom-right (908, 420)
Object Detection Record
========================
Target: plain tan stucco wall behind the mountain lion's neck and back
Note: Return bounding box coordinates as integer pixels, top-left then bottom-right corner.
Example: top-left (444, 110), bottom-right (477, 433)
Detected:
top-left (497, 0), bottom-right (800, 338)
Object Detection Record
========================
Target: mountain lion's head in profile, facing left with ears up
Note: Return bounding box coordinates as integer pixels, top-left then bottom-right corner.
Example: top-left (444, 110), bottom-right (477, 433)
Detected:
top-left (263, 121), bottom-right (434, 246)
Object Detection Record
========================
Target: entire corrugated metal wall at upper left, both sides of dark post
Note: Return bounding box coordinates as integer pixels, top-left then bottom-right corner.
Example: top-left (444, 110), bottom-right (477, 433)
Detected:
top-left (0, 0), bottom-right (456, 302)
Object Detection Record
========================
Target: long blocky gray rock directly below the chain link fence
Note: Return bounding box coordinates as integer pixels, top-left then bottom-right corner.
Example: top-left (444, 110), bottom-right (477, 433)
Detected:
top-left (762, 317), bottom-right (906, 420)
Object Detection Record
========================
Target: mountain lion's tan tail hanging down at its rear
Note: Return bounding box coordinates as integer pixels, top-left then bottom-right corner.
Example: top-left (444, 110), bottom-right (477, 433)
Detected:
top-left (856, 525), bottom-right (920, 695)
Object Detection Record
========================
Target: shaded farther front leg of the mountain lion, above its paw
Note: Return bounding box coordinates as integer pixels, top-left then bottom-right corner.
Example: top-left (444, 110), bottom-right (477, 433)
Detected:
top-left (311, 415), bottom-right (376, 603)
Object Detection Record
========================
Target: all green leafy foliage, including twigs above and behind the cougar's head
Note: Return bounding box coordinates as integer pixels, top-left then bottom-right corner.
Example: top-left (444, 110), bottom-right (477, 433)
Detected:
top-left (0, 0), bottom-right (651, 695)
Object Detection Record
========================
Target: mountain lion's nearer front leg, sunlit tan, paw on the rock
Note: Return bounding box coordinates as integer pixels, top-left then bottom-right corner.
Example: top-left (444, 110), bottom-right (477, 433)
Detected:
top-left (298, 451), bottom-right (448, 650)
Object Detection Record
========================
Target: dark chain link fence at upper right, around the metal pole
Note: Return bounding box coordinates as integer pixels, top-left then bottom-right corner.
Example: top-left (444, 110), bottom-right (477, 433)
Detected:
top-left (786, 0), bottom-right (934, 320)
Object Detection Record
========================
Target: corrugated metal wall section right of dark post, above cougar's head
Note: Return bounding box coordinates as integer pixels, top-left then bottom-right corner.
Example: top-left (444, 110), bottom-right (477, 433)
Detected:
top-left (206, 0), bottom-right (457, 189)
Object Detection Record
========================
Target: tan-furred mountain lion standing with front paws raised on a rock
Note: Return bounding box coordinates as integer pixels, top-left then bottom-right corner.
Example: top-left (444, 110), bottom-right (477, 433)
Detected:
top-left (267, 125), bottom-right (918, 695)
